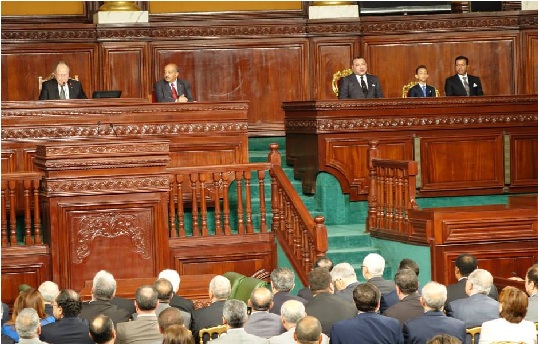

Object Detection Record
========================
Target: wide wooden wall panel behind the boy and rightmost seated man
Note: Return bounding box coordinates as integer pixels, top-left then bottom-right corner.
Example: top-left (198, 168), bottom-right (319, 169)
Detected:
top-left (363, 31), bottom-right (520, 98)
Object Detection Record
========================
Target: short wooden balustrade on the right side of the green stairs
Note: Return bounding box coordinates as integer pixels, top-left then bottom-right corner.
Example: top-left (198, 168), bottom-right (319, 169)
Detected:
top-left (367, 141), bottom-right (418, 233)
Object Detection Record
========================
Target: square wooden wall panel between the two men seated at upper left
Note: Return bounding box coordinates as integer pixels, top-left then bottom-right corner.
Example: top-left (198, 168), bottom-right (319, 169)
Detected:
top-left (98, 42), bottom-right (148, 99)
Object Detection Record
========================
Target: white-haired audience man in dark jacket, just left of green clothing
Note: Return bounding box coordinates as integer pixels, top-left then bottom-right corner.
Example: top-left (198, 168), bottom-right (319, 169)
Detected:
top-left (192, 275), bottom-right (229, 343)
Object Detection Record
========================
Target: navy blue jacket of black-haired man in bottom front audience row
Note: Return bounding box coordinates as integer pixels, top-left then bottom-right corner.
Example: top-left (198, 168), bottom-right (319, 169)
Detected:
top-left (331, 312), bottom-right (403, 344)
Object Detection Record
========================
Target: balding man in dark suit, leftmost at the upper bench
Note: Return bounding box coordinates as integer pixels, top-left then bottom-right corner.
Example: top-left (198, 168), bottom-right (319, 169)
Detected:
top-left (39, 61), bottom-right (87, 100)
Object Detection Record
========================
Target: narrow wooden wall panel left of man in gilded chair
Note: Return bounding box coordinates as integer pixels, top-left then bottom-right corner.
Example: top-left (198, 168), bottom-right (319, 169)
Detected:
top-left (307, 37), bottom-right (360, 99)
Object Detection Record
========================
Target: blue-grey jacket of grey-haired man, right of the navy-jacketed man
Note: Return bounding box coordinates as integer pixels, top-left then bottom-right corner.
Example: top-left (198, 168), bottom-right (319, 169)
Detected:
top-left (402, 311), bottom-right (465, 344)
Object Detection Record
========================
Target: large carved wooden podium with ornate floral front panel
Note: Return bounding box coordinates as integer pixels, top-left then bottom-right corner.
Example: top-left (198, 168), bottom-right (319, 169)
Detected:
top-left (35, 140), bottom-right (170, 290)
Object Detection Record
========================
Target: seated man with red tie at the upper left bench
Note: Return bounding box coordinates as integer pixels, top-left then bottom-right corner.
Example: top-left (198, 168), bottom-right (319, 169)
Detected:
top-left (153, 63), bottom-right (192, 103)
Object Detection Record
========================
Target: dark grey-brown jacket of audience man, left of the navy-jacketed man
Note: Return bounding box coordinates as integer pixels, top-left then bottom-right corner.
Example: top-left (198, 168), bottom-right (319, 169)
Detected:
top-left (306, 293), bottom-right (357, 336)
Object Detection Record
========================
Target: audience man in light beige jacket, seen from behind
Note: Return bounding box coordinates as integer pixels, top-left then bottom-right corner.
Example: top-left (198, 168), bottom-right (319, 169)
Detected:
top-left (116, 285), bottom-right (162, 344)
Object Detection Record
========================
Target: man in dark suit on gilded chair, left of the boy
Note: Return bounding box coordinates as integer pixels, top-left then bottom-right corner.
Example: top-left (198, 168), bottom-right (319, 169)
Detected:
top-left (338, 57), bottom-right (384, 99)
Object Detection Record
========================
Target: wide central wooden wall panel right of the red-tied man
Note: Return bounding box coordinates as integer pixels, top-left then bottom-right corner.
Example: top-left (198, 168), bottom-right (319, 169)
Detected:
top-left (151, 39), bottom-right (310, 130)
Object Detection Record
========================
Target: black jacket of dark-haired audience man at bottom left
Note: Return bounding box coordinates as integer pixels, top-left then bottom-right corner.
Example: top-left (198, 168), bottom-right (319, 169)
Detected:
top-left (39, 317), bottom-right (93, 344)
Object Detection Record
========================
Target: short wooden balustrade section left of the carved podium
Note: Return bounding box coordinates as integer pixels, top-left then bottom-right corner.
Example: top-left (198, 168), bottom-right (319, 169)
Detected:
top-left (2, 172), bottom-right (42, 247)
